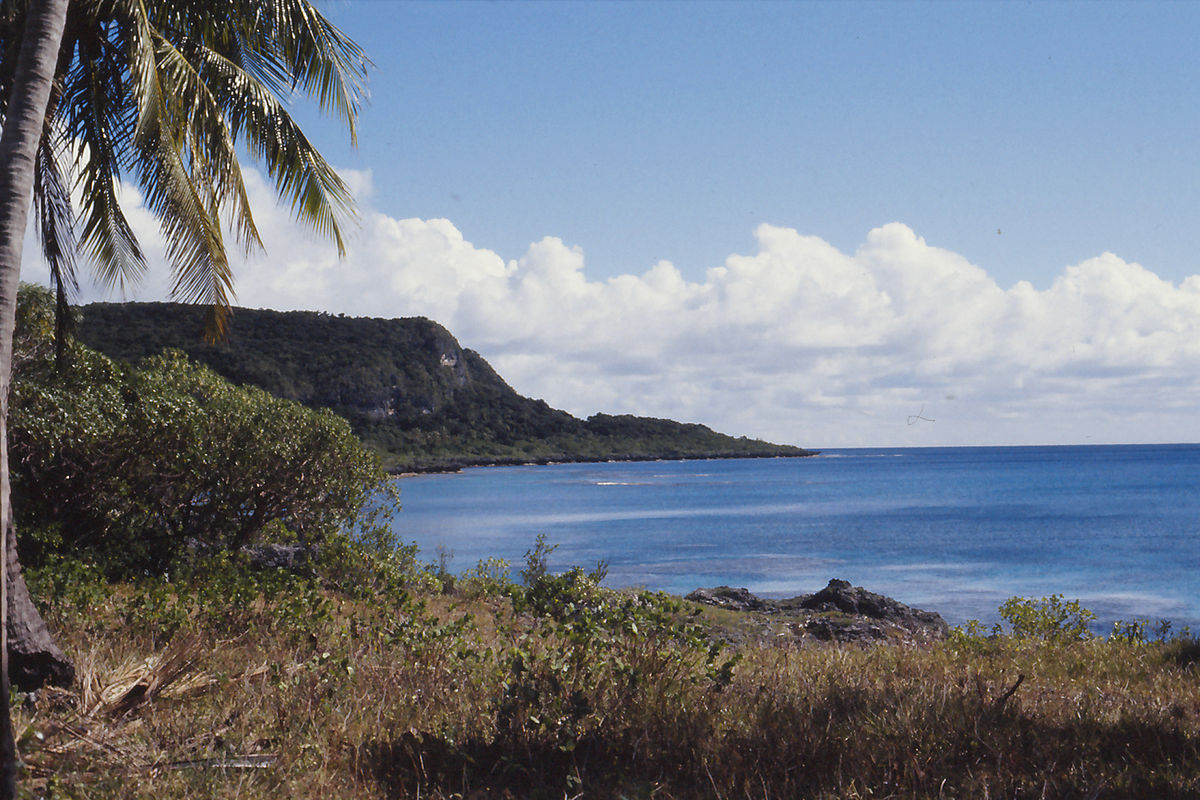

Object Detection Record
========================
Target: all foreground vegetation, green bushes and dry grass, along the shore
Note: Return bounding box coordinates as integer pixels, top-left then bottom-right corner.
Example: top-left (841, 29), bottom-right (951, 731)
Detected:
top-left (11, 290), bottom-right (1200, 800)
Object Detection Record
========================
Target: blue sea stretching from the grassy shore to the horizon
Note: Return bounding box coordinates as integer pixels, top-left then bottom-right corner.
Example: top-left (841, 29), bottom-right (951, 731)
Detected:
top-left (396, 445), bottom-right (1200, 630)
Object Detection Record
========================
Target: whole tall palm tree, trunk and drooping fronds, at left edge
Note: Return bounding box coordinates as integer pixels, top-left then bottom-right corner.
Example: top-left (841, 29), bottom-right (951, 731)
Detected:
top-left (0, 0), bottom-right (366, 786)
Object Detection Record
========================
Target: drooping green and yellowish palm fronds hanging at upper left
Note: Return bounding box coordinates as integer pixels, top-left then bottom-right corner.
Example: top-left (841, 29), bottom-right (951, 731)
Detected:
top-left (0, 0), bottom-right (368, 333)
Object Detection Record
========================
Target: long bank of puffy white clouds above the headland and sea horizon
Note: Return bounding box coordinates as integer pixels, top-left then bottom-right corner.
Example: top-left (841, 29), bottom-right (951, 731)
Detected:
top-left (60, 174), bottom-right (1200, 447)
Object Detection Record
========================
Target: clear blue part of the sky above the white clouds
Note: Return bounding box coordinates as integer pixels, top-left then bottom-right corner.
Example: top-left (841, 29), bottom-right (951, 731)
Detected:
top-left (295, 0), bottom-right (1200, 285)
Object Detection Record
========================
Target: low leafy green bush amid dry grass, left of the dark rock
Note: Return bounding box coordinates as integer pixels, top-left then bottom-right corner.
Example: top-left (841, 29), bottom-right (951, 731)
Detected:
top-left (496, 536), bottom-right (740, 767)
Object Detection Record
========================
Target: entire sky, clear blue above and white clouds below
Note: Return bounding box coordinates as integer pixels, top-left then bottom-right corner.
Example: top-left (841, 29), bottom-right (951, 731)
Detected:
top-left (44, 0), bottom-right (1200, 447)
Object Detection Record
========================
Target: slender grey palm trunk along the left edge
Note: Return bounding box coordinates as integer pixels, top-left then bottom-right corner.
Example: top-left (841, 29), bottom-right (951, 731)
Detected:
top-left (0, 0), bottom-right (68, 800)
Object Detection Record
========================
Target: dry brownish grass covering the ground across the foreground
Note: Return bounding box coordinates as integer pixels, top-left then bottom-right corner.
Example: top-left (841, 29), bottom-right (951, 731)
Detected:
top-left (16, 568), bottom-right (1200, 800)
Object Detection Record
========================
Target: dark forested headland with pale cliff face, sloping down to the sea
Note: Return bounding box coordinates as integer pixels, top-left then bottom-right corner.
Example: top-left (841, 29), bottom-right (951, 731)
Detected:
top-left (78, 303), bottom-right (811, 471)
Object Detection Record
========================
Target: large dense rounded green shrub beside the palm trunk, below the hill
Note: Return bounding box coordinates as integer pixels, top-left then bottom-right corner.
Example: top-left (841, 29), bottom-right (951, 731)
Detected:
top-left (10, 284), bottom-right (386, 573)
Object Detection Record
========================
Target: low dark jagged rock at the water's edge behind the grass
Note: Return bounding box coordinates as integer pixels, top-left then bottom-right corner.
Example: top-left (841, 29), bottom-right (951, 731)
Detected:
top-left (685, 578), bottom-right (950, 642)
